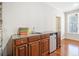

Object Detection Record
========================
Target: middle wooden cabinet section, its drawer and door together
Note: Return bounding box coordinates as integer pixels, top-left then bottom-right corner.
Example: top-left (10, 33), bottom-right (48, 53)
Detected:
top-left (28, 35), bottom-right (41, 56)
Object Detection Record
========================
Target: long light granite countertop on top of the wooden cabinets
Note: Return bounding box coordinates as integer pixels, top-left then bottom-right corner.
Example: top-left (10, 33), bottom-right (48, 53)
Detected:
top-left (11, 31), bottom-right (57, 39)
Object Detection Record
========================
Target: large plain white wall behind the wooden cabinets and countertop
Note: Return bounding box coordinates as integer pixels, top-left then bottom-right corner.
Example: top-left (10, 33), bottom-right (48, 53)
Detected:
top-left (2, 2), bottom-right (64, 51)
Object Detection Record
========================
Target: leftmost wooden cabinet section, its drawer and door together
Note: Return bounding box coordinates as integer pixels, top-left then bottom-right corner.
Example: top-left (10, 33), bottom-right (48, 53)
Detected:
top-left (12, 38), bottom-right (28, 56)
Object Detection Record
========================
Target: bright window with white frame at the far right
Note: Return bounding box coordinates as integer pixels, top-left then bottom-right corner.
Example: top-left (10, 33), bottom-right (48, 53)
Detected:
top-left (68, 14), bottom-right (79, 33)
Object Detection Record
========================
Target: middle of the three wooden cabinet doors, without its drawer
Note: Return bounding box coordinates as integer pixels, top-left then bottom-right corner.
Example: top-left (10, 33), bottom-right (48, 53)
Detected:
top-left (29, 41), bottom-right (40, 56)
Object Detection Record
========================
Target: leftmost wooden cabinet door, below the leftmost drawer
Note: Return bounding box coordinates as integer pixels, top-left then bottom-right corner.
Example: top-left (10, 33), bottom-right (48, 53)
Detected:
top-left (16, 44), bottom-right (28, 56)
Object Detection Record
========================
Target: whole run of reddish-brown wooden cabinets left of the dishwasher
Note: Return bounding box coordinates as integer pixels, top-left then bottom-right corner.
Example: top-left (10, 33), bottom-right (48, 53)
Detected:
top-left (7, 34), bottom-right (50, 56)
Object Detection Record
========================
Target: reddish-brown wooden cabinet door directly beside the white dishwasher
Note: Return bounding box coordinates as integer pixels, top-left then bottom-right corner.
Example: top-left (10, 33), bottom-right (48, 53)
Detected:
top-left (41, 38), bottom-right (49, 56)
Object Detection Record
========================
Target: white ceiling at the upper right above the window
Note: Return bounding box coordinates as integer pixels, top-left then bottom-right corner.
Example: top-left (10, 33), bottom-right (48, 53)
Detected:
top-left (47, 2), bottom-right (79, 12)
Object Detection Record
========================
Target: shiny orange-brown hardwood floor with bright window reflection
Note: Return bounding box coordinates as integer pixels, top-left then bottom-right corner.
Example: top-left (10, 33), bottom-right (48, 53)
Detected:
top-left (50, 39), bottom-right (79, 56)
